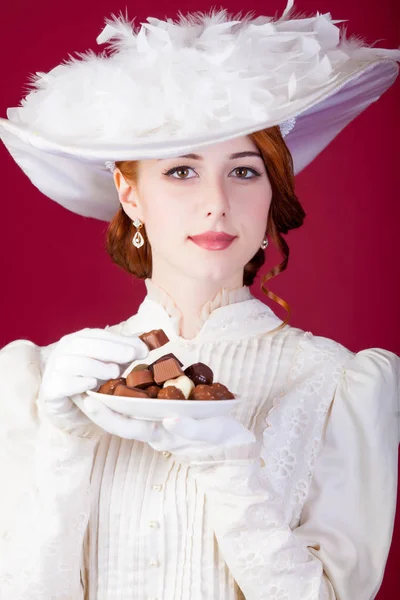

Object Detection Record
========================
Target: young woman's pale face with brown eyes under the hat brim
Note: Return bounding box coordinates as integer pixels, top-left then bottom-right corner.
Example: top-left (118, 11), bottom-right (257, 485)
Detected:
top-left (117, 136), bottom-right (272, 284)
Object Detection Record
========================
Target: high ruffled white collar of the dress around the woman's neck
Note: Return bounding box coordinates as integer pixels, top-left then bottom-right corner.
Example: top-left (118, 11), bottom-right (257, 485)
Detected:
top-left (125, 279), bottom-right (282, 345)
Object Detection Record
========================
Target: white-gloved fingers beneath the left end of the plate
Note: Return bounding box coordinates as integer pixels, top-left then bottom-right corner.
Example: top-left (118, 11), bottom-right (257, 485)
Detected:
top-left (81, 397), bottom-right (160, 442)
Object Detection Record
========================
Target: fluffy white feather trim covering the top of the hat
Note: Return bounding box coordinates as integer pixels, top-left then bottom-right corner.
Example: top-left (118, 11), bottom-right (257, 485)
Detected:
top-left (8, 0), bottom-right (400, 145)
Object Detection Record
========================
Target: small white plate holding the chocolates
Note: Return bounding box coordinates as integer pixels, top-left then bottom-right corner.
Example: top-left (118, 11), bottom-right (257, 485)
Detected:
top-left (87, 390), bottom-right (239, 421)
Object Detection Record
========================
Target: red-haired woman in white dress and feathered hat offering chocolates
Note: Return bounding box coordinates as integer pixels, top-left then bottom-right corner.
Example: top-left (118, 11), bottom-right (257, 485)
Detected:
top-left (0, 2), bottom-right (400, 600)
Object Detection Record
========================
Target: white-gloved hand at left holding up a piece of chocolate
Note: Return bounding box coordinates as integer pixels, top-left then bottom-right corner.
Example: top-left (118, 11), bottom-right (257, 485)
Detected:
top-left (38, 329), bottom-right (149, 437)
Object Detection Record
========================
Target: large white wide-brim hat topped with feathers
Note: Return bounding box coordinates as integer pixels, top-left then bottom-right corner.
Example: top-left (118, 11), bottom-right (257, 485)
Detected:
top-left (0, 0), bottom-right (400, 221)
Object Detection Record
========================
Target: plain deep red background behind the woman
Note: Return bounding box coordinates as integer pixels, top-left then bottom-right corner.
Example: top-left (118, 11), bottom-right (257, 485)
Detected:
top-left (0, 0), bottom-right (400, 600)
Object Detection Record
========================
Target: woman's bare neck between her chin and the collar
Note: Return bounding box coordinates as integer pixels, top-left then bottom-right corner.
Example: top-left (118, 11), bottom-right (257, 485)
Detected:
top-left (151, 265), bottom-right (243, 339)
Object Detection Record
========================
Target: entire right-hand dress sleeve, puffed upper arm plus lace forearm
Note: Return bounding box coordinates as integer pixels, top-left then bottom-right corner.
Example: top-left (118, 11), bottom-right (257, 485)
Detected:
top-left (188, 349), bottom-right (399, 600)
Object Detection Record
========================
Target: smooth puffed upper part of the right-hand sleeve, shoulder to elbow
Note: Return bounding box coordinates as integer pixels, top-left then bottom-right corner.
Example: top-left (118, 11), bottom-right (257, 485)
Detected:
top-left (294, 349), bottom-right (400, 600)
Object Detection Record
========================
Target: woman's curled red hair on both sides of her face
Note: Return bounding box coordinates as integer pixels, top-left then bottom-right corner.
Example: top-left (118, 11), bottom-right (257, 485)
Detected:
top-left (106, 127), bottom-right (306, 329)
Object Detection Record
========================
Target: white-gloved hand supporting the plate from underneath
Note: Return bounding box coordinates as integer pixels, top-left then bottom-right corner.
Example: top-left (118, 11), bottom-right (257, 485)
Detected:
top-left (84, 397), bottom-right (256, 460)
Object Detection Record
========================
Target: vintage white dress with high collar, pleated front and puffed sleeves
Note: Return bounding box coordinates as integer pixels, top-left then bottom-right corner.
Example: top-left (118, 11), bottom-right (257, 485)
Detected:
top-left (0, 280), bottom-right (400, 600)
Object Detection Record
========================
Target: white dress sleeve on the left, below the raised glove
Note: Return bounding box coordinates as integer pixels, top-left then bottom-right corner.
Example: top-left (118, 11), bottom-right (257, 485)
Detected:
top-left (0, 340), bottom-right (99, 600)
